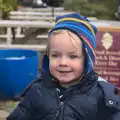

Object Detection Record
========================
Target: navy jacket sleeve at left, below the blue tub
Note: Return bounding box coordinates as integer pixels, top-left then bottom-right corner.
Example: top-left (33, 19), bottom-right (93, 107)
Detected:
top-left (7, 84), bottom-right (35, 120)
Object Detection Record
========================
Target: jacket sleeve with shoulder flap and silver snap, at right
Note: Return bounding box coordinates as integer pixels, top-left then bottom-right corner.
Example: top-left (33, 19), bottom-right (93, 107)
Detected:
top-left (98, 81), bottom-right (120, 120)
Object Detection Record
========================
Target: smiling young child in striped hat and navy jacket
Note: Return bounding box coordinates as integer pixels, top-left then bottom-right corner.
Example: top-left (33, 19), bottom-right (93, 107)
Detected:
top-left (7, 13), bottom-right (120, 120)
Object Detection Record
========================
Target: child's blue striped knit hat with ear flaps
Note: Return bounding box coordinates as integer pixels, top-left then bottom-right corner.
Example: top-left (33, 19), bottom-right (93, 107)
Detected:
top-left (42, 13), bottom-right (97, 75)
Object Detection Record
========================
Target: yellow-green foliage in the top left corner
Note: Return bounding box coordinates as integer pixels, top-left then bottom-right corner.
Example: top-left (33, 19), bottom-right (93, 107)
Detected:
top-left (0, 0), bottom-right (17, 19)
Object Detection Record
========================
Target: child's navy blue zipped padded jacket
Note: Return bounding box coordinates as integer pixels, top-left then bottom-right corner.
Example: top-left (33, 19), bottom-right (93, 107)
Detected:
top-left (7, 72), bottom-right (120, 120)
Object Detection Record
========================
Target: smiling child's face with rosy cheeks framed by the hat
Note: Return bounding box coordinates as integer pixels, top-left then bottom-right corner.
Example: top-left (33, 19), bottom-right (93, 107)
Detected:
top-left (49, 31), bottom-right (84, 85)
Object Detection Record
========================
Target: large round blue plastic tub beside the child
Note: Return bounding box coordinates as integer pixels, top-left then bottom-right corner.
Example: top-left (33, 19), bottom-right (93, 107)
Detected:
top-left (0, 49), bottom-right (38, 99)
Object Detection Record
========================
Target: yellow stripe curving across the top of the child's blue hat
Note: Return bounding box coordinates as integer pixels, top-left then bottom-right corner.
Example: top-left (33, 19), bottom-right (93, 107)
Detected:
top-left (56, 18), bottom-right (95, 36)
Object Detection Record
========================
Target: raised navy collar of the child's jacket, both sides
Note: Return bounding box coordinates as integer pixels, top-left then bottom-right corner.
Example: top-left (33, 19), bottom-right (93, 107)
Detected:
top-left (41, 71), bottom-right (98, 92)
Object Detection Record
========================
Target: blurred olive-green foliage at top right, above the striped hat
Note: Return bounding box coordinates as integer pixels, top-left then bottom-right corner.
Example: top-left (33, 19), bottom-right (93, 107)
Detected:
top-left (64, 0), bottom-right (117, 19)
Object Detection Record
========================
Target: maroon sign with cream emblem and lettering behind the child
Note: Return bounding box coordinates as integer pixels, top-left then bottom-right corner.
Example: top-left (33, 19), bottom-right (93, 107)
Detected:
top-left (95, 29), bottom-right (120, 88)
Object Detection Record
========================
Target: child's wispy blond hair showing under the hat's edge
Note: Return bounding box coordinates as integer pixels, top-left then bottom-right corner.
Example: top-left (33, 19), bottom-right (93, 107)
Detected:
top-left (46, 29), bottom-right (81, 55)
